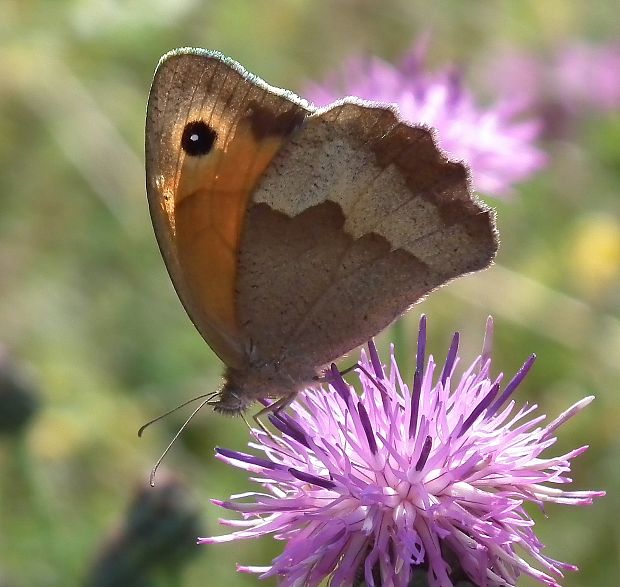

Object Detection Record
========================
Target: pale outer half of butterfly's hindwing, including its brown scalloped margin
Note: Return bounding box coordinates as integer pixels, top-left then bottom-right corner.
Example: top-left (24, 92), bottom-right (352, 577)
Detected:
top-left (253, 100), bottom-right (497, 274)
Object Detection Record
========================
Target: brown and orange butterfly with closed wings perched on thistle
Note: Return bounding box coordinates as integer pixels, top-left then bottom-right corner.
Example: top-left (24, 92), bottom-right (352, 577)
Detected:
top-left (146, 48), bottom-right (497, 414)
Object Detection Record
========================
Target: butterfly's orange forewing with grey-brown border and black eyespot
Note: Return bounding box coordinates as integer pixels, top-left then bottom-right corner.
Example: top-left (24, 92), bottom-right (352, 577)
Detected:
top-left (146, 50), bottom-right (308, 366)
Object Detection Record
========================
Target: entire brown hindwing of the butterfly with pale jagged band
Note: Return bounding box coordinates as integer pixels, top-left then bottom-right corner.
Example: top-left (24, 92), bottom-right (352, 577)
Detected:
top-left (238, 102), bottom-right (497, 366)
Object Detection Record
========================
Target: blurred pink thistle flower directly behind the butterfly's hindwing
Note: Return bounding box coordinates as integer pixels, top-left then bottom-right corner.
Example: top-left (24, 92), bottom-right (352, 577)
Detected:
top-left (305, 45), bottom-right (547, 196)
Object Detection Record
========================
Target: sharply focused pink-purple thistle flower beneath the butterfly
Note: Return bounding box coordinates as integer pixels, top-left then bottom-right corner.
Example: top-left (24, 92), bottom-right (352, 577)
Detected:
top-left (199, 317), bottom-right (604, 587)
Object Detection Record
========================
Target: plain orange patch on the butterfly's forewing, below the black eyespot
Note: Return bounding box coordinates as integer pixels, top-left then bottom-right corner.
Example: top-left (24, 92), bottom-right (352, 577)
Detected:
top-left (174, 125), bottom-right (283, 336)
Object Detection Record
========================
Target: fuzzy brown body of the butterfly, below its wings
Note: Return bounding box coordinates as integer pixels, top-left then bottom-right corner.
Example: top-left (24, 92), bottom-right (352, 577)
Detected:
top-left (214, 362), bottom-right (317, 416)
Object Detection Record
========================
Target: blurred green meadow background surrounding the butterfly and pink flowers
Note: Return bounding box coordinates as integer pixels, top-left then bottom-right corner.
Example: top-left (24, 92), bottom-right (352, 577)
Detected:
top-left (0, 0), bottom-right (620, 587)
